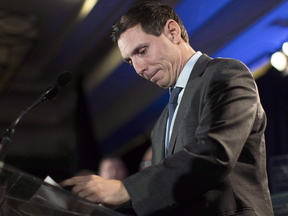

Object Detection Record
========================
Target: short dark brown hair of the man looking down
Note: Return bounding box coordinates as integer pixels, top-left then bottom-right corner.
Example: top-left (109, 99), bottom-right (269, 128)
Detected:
top-left (111, 1), bottom-right (189, 43)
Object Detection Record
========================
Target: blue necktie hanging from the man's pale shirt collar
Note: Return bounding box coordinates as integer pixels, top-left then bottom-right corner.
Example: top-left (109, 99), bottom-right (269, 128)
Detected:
top-left (165, 87), bottom-right (182, 156)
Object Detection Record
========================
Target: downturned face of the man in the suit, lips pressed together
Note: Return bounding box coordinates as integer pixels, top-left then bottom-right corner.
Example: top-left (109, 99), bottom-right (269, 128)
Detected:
top-left (118, 24), bottom-right (180, 88)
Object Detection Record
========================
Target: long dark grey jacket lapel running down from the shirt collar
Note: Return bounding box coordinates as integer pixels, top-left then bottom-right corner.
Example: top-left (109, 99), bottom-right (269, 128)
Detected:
top-left (168, 54), bottom-right (212, 156)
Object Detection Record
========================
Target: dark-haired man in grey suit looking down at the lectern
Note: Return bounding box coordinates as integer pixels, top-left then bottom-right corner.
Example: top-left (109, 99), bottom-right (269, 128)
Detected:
top-left (62, 2), bottom-right (273, 216)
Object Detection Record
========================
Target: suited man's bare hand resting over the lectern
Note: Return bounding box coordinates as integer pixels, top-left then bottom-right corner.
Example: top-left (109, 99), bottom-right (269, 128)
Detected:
top-left (59, 175), bottom-right (130, 206)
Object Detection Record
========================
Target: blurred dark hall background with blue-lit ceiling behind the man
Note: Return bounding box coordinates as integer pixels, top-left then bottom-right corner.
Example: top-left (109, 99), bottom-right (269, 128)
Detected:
top-left (0, 0), bottom-right (288, 194)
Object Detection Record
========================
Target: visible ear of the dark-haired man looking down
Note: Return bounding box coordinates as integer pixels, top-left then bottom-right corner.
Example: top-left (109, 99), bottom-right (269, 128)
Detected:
top-left (164, 19), bottom-right (181, 44)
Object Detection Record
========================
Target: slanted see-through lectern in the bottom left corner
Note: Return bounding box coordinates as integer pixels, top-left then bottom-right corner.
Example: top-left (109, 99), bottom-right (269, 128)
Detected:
top-left (0, 161), bottom-right (124, 216)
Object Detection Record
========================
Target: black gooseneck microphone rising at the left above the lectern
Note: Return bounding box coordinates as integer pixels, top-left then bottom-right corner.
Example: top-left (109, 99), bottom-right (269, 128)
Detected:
top-left (0, 72), bottom-right (72, 161)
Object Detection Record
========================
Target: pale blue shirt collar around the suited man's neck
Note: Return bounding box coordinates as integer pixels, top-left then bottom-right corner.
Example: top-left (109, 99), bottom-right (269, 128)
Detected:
top-left (169, 51), bottom-right (202, 94)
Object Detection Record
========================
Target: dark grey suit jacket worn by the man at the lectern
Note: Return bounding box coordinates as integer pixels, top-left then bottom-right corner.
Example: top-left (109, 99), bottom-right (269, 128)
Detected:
top-left (123, 55), bottom-right (273, 216)
